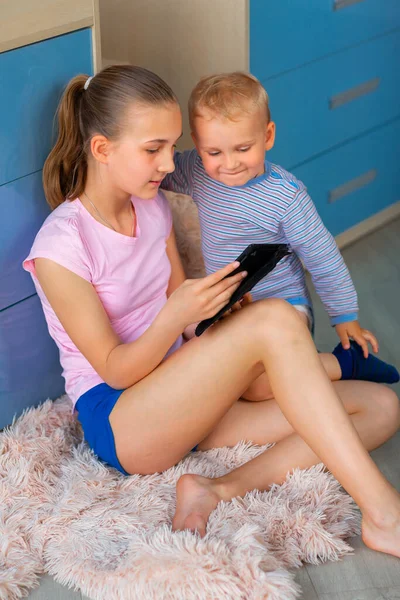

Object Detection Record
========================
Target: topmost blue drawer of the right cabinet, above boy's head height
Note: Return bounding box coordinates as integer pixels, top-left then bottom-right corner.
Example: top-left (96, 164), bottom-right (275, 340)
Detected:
top-left (249, 0), bottom-right (400, 79)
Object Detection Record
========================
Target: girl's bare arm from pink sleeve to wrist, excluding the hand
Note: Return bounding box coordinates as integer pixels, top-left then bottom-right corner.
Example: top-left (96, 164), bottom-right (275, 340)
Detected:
top-left (35, 258), bottom-right (183, 389)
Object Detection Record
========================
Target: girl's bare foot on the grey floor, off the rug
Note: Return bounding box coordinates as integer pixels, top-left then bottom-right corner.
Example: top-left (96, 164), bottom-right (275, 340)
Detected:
top-left (362, 510), bottom-right (400, 558)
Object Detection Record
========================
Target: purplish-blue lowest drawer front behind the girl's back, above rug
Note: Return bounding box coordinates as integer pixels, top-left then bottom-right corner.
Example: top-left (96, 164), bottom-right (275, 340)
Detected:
top-left (0, 295), bottom-right (64, 428)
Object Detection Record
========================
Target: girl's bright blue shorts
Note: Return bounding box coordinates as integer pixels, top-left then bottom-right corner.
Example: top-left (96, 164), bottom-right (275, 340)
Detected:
top-left (75, 383), bottom-right (129, 475)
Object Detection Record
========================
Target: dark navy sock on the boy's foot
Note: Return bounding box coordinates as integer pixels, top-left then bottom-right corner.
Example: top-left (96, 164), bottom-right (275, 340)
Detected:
top-left (332, 342), bottom-right (400, 383)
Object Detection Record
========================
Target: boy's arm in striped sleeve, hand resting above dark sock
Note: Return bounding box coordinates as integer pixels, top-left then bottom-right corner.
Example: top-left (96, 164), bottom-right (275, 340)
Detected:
top-left (282, 188), bottom-right (378, 356)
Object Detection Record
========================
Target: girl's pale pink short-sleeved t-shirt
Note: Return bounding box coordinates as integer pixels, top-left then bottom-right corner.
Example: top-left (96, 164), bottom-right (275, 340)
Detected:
top-left (23, 193), bottom-right (182, 404)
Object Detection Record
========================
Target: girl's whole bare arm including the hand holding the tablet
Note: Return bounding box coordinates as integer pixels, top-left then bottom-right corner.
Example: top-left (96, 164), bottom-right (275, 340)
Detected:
top-left (35, 252), bottom-right (240, 389)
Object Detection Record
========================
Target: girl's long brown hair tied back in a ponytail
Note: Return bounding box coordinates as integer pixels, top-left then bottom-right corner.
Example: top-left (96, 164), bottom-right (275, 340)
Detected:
top-left (43, 65), bottom-right (178, 209)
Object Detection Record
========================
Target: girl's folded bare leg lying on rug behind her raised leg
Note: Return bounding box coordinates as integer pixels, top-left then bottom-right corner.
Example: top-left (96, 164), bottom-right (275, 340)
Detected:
top-left (174, 381), bottom-right (400, 554)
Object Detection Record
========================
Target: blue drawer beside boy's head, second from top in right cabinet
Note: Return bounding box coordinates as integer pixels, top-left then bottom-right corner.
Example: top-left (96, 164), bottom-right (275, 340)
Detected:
top-left (266, 32), bottom-right (400, 169)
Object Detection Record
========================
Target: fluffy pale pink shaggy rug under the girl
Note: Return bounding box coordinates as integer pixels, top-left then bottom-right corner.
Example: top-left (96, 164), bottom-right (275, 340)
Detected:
top-left (0, 398), bottom-right (359, 600)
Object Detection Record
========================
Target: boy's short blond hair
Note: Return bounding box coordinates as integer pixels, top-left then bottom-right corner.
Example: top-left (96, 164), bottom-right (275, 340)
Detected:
top-left (189, 71), bottom-right (271, 131)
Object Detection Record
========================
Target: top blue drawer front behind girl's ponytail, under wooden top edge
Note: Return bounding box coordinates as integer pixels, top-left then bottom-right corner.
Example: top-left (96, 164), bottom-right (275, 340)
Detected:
top-left (0, 29), bottom-right (92, 185)
